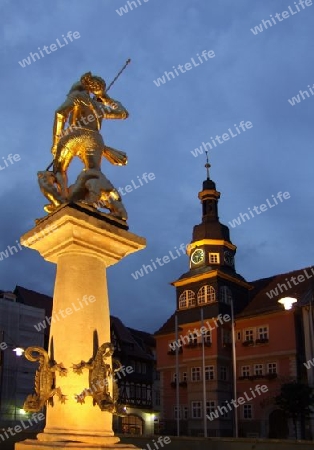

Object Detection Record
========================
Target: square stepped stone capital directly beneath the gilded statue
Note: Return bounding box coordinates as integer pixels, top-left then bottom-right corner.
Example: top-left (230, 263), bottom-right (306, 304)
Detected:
top-left (21, 203), bottom-right (146, 267)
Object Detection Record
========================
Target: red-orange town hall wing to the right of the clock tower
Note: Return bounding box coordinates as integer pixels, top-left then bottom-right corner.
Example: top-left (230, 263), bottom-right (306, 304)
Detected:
top-left (235, 267), bottom-right (314, 439)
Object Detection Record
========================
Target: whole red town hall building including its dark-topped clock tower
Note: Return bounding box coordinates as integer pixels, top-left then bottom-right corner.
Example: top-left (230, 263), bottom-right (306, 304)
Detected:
top-left (155, 165), bottom-right (314, 439)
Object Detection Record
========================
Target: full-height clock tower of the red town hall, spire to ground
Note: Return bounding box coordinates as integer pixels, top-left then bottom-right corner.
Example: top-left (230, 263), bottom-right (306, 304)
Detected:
top-left (155, 159), bottom-right (251, 436)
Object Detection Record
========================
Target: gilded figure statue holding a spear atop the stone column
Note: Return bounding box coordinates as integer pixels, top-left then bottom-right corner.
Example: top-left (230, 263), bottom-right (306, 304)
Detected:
top-left (38, 68), bottom-right (129, 221)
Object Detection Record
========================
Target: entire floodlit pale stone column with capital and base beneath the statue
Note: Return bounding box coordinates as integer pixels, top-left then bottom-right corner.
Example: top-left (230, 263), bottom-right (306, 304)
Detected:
top-left (15, 204), bottom-right (146, 450)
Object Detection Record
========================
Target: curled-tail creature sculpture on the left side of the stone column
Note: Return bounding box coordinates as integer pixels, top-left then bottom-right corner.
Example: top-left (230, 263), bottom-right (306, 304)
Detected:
top-left (23, 347), bottom-right (68, 412)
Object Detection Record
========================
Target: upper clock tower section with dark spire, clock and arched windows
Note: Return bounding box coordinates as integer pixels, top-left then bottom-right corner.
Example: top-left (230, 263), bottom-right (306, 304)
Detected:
top-left (172, 153), bottom-right (250, 320)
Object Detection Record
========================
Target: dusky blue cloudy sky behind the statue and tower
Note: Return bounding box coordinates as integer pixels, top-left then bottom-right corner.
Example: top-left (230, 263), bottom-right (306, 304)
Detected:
top-left (0, 0), bottom-right (314, 332)
